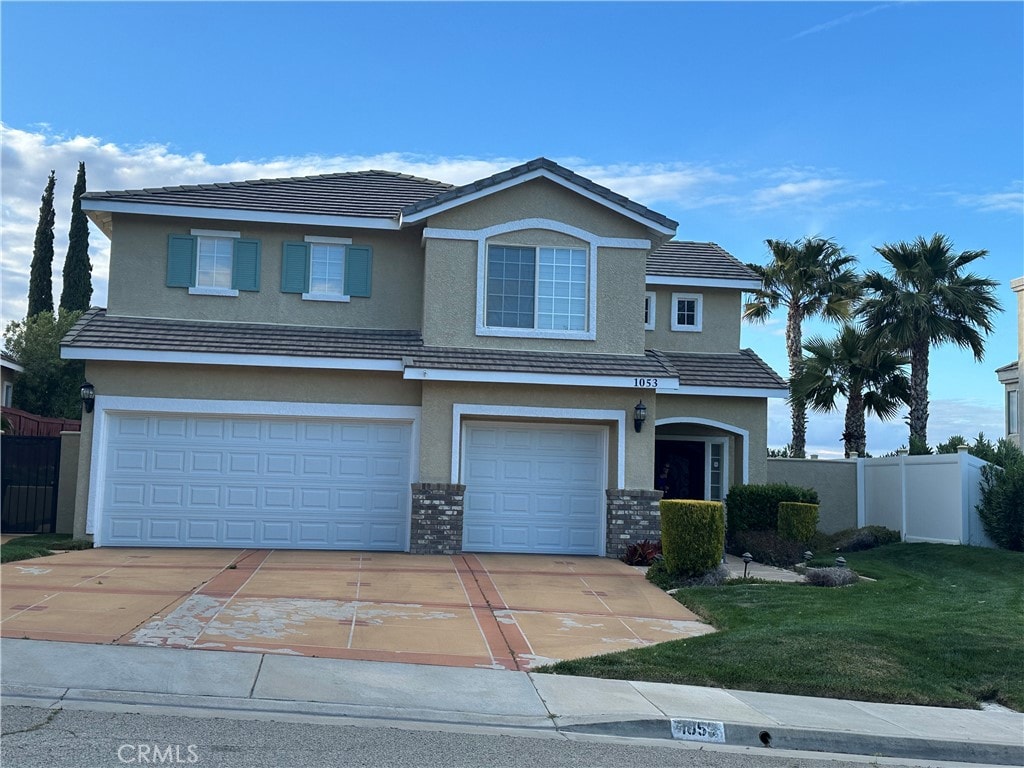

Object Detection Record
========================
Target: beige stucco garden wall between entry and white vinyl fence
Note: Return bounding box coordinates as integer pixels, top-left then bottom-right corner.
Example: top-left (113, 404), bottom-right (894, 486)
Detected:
top-left (768, 459), bottom-right (857, 534)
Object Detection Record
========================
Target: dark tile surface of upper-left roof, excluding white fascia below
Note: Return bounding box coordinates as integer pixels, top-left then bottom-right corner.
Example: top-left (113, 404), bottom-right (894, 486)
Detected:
top-left (82, 171), bottom-right (453, 219)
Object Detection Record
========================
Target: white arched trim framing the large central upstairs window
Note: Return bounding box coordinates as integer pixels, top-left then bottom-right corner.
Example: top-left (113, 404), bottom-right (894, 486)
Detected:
top-left (460, 219), bottom-right (602, 341)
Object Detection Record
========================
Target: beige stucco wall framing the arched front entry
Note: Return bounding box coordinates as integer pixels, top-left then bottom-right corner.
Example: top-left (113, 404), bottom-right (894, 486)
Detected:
top-left (647, 394), bottom-right (768, 486)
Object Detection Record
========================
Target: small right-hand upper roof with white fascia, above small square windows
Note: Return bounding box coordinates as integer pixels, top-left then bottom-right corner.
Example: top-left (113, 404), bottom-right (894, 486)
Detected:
top-left (647, 240), bottom-right (761, 290)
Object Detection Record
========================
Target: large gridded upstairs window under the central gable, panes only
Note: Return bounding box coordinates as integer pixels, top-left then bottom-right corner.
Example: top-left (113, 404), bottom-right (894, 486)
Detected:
top-left (485, 245), bottom-right (589, 332)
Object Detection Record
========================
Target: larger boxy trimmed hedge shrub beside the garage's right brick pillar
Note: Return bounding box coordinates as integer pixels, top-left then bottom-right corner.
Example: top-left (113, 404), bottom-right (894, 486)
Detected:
top-left (660, 499), bottom-right (725, 577)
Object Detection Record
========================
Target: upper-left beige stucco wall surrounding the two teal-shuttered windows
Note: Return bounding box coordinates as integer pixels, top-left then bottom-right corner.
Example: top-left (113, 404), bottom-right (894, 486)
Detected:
top-left (108, 214), bottom-right (423, 330)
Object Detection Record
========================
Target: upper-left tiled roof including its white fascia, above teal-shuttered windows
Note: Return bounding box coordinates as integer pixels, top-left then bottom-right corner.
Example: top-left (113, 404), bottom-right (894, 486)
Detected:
top-left (82, 171), bottom-right (453, 229)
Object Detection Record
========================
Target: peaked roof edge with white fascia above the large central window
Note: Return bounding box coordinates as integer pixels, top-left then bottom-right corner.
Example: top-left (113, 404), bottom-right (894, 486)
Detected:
top-left (402, 158), bottom-right (679, 234)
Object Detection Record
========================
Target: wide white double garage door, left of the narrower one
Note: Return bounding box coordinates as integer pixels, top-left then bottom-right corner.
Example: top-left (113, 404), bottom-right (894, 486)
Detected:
top-left (98, 414), bottom-right (412, 550)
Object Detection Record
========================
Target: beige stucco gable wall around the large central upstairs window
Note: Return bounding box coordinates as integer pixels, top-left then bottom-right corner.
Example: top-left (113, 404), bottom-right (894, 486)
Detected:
top-left (423, 179), bottom-right (650, 354)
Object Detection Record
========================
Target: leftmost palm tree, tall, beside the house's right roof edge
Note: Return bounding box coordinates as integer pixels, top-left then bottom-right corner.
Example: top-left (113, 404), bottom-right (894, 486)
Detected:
top-left (743, 238), bottom-right (860, 458)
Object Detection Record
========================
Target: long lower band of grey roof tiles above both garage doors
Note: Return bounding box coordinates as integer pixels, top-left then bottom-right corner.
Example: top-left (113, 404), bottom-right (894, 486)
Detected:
top-left (60, 309), bottom-right (785, 388)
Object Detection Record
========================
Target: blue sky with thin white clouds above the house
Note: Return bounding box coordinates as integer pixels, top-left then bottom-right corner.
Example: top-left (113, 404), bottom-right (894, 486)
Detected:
top-left (0, 2), bottom-right (1024, 455)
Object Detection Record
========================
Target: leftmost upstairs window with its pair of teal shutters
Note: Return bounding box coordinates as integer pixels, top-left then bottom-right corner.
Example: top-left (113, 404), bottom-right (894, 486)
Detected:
top-left (167, 229), bottom-right (260, 296)
